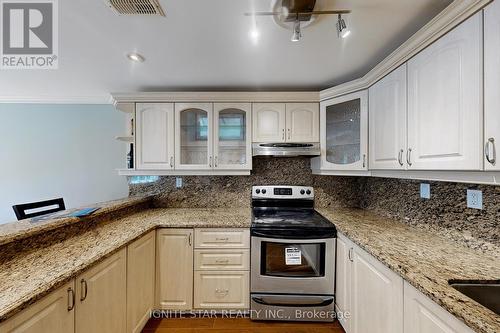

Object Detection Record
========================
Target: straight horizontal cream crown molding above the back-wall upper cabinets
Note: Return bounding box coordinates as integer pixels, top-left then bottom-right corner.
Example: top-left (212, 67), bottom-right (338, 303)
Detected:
top-left (111, 91), bottom-right (319, 104)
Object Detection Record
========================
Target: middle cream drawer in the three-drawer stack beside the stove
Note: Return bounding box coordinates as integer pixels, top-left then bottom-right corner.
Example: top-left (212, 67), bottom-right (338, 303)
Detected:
top-left (194, 249), bottom-right (250, 271)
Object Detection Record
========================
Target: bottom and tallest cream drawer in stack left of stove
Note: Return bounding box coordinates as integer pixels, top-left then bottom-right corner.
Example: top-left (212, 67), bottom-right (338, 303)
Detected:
top-left (194, 271), bottom-right (250, 309)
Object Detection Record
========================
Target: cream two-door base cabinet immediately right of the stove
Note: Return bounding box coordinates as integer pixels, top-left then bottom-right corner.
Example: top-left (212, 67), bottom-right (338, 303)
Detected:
top-left (336, 234), bottom-right (403, 333)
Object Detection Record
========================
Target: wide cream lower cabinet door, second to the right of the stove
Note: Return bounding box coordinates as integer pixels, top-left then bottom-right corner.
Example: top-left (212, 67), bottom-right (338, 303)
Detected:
top-left (351, 246), bottom-right (403, 333)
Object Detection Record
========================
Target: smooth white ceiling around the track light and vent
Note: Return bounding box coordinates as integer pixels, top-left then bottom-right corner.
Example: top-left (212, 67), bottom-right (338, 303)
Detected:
top-left (0, 0), bottom-right (451, 102)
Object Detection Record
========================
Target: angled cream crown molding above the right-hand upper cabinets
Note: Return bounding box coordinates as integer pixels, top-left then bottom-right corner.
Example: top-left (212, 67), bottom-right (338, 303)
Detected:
top-left (319, 0), bottom-right (493, 101)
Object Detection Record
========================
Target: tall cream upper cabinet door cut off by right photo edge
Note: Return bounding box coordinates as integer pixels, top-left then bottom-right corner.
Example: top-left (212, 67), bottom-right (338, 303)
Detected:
top-left (484, 1), bottom-right (500, 170)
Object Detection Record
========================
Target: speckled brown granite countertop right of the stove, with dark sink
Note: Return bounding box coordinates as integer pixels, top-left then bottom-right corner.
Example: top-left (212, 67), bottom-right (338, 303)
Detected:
top-left (317, 208), bottom-right (500, 333)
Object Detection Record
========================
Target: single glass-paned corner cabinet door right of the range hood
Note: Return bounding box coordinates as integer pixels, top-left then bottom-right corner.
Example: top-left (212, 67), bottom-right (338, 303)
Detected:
top-left (320, 90), bottom-right (368, 170)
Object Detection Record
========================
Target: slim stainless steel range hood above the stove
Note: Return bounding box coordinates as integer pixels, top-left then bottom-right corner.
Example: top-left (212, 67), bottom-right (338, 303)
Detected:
top-left (252, 142), bottom-right (320, 156)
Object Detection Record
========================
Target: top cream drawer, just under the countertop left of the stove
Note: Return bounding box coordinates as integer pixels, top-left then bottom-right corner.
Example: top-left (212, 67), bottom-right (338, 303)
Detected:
top-left (194, 229), bottom-right (250, 249)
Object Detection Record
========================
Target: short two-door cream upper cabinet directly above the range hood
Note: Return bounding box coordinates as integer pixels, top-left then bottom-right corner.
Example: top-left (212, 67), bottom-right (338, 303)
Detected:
top-left (252, 103), bottom-right (319, 143)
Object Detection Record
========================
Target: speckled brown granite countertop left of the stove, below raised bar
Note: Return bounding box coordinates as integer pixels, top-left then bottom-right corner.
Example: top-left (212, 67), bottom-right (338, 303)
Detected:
top-left (0, 208), bottom-right (251, 322)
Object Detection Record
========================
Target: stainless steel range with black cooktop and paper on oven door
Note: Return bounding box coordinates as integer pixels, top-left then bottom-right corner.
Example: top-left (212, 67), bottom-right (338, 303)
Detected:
top-left (250, 186), bottom-right (337, 321)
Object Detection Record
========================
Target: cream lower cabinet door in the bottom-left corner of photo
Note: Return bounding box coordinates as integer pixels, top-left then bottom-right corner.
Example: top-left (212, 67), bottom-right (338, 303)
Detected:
top-left (0, 280), bottom-right (75, 333)
